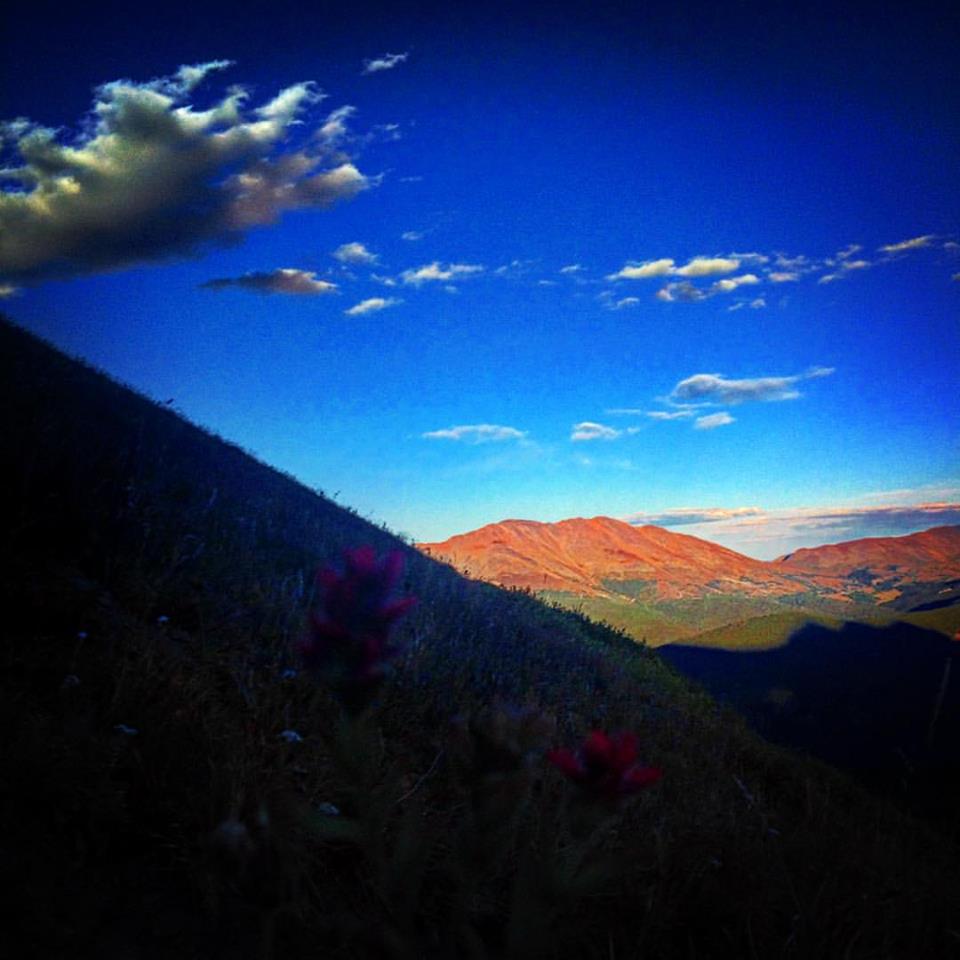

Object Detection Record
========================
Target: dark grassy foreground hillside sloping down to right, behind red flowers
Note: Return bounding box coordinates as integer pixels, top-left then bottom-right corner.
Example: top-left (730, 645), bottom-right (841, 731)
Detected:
top-left (0, 322), bottom-right (960, 960)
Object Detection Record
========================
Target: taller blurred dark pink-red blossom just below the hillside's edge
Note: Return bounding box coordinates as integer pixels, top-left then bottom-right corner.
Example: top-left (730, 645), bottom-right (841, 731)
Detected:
top-left (299, 547), bottom-right (416, 712)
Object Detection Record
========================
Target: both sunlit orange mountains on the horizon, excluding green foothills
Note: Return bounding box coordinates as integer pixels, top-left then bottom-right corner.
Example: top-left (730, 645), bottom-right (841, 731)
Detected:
top-left (419, 517), bottom-right (960, 602)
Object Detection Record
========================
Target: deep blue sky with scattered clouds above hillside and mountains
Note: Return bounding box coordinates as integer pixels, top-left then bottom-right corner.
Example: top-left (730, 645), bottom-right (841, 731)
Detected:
top-left (0, 3), bottom-right (960, 557)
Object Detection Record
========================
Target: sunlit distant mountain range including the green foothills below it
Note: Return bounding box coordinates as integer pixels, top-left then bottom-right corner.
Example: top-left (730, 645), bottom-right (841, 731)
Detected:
top-left (418, 517), bottom-right (960, 643)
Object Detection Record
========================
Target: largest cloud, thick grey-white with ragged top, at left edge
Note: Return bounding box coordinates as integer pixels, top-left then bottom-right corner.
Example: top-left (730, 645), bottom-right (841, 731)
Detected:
top-left (0, 60), bottom-right (372, 284)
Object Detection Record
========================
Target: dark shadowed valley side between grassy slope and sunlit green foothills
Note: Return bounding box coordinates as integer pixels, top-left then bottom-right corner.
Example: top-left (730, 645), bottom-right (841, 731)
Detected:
top-left (658, 622), bottom-right (960, 817)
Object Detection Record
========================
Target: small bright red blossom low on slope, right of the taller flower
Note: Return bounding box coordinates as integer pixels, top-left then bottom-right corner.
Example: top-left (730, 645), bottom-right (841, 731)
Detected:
top-left (547, 730), bottom-right (663, 801)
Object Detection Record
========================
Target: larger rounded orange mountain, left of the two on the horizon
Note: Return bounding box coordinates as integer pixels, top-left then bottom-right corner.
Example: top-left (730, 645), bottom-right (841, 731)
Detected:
top-left (418, 517), bottom-right (809, 600)
